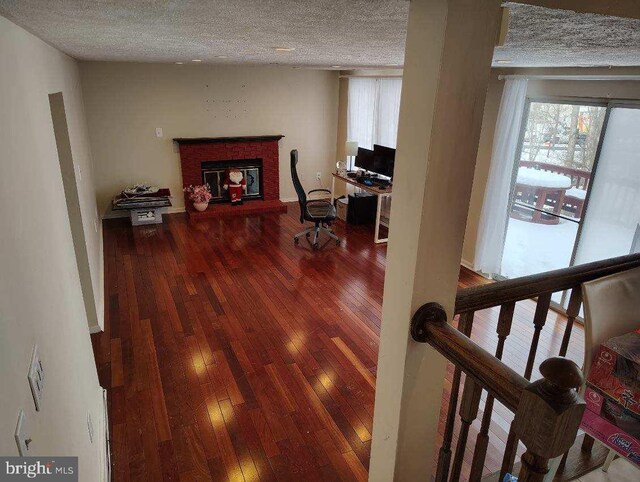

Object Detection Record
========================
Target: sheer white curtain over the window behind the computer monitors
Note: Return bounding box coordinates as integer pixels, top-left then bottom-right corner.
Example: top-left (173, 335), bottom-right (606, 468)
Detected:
top-left (347, 78), bottom-right (402, 149)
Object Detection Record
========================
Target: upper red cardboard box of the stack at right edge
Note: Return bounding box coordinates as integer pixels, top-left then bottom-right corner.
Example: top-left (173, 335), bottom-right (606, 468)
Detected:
top-left (587, 330), bottom-right (640, 415)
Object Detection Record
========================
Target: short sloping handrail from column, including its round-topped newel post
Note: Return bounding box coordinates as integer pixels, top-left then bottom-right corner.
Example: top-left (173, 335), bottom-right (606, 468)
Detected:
top-left (411, 303), bottom-right (585, 482)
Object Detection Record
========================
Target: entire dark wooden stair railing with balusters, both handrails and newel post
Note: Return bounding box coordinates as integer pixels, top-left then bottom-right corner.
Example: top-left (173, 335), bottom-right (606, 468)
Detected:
top-left (411, 254), bottom-right (640, 482)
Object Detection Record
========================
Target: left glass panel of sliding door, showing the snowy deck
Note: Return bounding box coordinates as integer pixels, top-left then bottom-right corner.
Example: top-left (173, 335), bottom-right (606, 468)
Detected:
top-left (499, 101), bottom-right (607, 278)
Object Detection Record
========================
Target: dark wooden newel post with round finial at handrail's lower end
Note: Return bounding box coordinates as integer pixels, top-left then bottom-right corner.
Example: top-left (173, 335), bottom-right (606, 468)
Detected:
top-left (513, 357), bottom-right (585, 482)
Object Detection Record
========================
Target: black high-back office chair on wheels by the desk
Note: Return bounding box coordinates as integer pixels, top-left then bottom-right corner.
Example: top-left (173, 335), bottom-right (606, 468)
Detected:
top-left (291, 149), bottom-right (340, 249)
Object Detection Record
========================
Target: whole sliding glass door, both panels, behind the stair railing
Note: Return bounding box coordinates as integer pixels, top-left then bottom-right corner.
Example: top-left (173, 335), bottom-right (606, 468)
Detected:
top-left (497, 101), bottom-right (640, 310)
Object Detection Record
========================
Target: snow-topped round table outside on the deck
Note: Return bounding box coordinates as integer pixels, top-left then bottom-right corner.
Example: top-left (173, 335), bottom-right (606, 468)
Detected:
top-left (511, 167), bottom-right (572, 224)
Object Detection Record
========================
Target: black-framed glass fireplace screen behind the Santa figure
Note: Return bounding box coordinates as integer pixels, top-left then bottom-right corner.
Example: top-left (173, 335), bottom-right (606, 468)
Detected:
top-left (202, 159), bottom-right (262, 203)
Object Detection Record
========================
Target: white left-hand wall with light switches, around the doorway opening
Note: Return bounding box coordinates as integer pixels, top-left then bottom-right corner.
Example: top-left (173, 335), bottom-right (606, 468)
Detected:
top-left (0, 17), bottom-right (104, 481)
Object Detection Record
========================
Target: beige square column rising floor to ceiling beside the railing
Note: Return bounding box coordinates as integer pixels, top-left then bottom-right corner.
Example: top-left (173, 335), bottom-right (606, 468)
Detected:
top-left (369, 0), bottom-right (501, 482)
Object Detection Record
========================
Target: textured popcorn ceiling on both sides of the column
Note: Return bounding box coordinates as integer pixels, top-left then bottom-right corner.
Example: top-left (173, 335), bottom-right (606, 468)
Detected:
top-left (0, 0), bottom-right (640, 69)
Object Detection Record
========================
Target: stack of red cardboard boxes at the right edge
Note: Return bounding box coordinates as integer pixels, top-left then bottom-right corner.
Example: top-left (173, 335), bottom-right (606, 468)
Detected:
top-left (581, 330), bottom-right (640, 465)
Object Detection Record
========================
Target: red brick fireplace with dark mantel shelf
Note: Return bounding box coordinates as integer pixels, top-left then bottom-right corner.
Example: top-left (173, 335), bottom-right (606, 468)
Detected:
top-left (174, 135), bottom-right (287, 217)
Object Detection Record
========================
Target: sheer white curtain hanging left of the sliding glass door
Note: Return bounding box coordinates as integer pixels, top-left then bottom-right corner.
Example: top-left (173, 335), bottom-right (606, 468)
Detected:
top-left (474, 79), bottom-right (527, 274)
